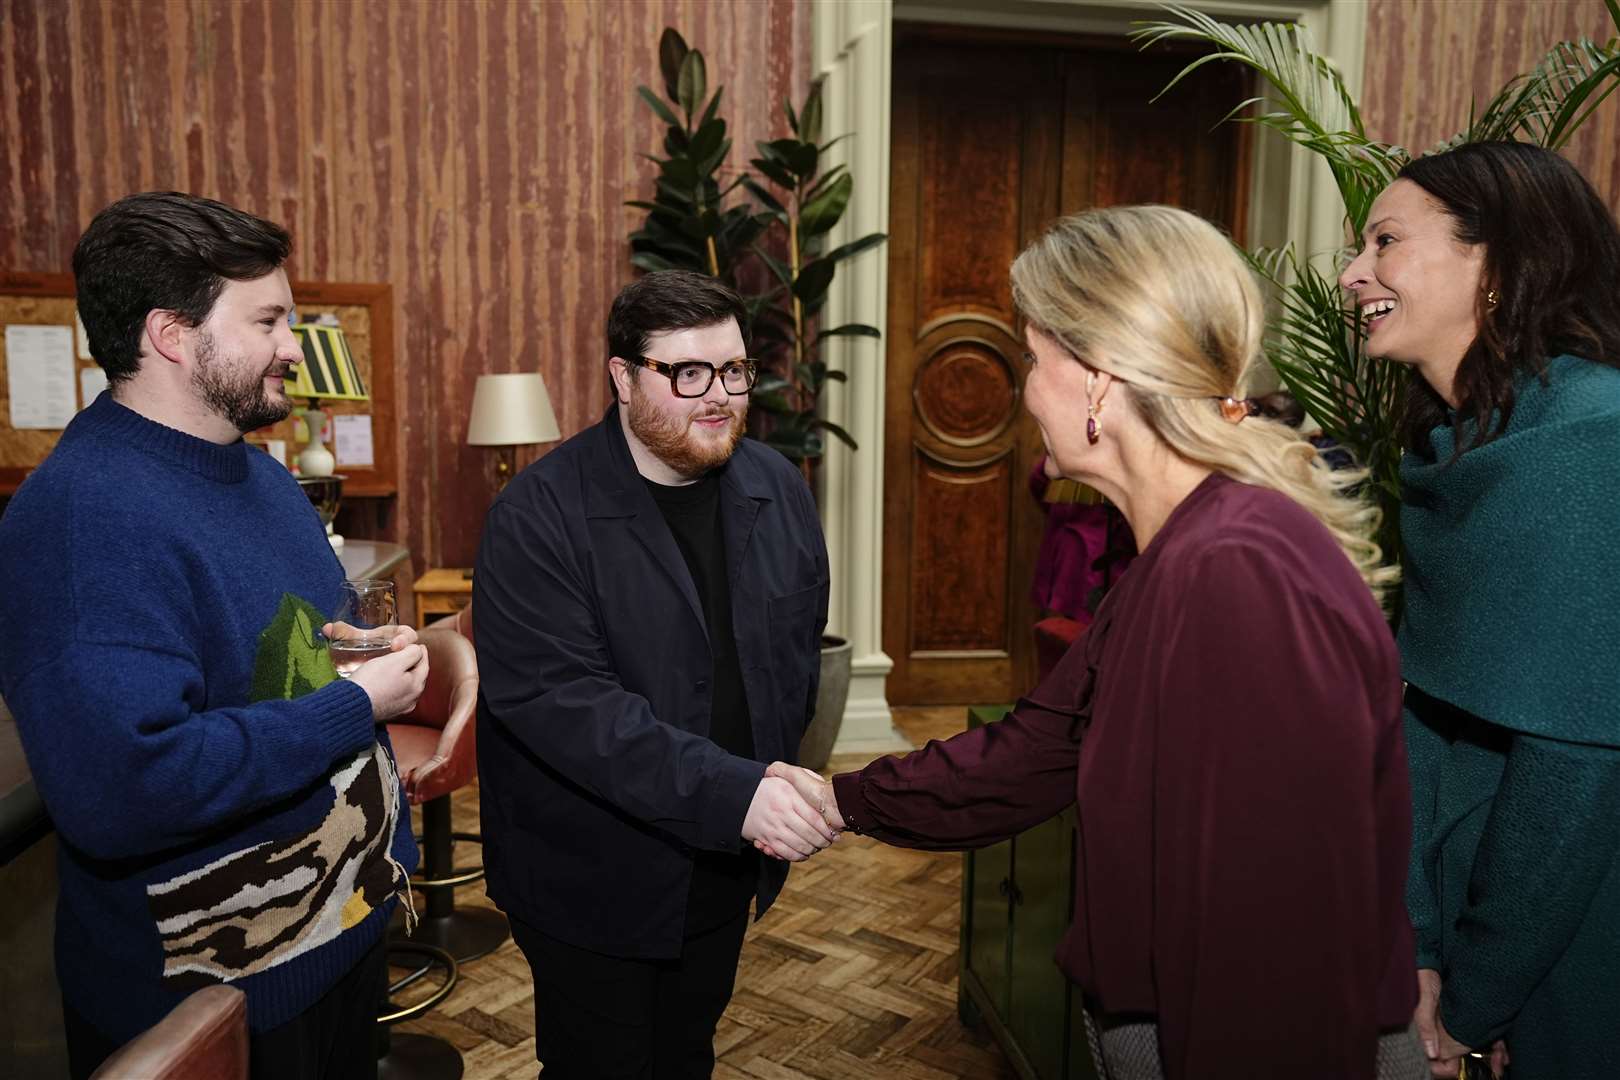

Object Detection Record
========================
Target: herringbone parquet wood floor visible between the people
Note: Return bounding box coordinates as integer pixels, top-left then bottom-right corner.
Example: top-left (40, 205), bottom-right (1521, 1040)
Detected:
top-left (400, 708), bottom-right (1014, 1080)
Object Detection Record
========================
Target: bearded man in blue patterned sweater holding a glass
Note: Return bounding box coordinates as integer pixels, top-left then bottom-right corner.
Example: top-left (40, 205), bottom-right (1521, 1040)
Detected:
top-left (0, 193), bottom-right (428, 1080)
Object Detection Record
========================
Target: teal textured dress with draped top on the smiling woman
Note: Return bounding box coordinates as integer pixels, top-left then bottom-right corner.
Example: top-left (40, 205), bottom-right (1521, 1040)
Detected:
top-left (1400, 356), bottom-right (1620, 1080)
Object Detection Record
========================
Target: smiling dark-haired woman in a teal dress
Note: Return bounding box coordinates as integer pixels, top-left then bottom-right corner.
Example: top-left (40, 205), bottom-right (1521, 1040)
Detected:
top-left (1340, 142), bottom-right (1620, 1080)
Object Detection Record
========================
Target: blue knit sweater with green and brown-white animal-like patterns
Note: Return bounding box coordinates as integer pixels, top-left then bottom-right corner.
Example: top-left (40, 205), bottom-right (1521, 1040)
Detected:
top-left (0, 393), bottom-right (416, 1040)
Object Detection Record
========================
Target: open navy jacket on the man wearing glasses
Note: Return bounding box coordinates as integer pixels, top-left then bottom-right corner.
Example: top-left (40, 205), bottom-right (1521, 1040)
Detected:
top-left (473, 406), bottom-right (828, 959)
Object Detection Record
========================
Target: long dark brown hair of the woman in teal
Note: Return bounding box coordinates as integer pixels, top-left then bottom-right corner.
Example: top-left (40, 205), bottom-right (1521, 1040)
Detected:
top-left (1398, 142), bottom-right (1620, 455)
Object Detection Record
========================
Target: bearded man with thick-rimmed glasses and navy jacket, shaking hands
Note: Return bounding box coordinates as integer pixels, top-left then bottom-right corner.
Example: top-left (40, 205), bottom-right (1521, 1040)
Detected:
top-left (473, 270), bottom-right (822, 1080)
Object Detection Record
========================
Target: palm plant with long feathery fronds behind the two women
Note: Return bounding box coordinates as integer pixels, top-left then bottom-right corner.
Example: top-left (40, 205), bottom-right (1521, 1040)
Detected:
top-left (1132, 0), bottom-right (1620, 560)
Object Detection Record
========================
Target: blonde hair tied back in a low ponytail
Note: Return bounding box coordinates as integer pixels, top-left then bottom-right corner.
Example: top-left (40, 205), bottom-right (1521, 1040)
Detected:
top-left (1013, 206), bottom-right (1400, 601)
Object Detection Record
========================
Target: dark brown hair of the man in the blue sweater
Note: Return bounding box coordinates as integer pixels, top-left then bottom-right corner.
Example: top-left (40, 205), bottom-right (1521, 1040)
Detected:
top-left (73, 191), bottom-right (292, 382)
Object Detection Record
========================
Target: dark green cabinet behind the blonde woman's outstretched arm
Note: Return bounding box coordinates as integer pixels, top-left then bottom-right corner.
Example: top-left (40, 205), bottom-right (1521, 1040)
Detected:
top-left (957, 706), bottom-right (1097, 1080)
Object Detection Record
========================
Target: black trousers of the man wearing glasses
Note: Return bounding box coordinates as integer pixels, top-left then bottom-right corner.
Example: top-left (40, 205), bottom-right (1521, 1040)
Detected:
top-left (512, 910), bottom-right (748, 1080)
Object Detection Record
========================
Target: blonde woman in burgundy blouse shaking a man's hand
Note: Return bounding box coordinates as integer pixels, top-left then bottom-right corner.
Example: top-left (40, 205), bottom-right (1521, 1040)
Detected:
top-left (758, 206), bottom-right (1427, 1080)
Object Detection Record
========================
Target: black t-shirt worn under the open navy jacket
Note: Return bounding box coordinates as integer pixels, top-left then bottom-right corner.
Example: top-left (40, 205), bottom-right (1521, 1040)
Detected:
top-left (646, 473), bottom-right (758, 938)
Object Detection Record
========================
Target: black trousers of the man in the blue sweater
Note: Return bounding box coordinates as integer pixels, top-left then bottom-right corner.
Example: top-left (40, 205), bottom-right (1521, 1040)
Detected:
top-left (62, 934), bottom-right (389, 1080)
